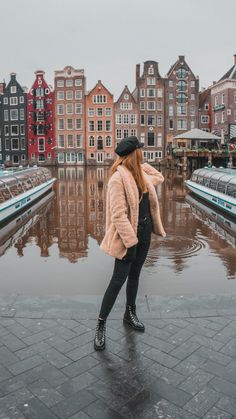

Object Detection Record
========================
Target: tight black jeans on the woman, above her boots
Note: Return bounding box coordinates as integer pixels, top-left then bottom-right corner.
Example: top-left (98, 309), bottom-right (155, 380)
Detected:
top-left (99, 217), bottom-right (152, 319)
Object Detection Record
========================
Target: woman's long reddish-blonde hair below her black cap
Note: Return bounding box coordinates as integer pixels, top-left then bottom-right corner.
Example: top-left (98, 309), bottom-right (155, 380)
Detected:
top-left (110, 148), bottom-right (147, 196)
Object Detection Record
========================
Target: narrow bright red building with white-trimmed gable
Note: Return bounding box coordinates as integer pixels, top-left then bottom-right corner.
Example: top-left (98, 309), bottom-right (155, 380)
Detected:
top-left (27, 71), bottom-right (55, 164)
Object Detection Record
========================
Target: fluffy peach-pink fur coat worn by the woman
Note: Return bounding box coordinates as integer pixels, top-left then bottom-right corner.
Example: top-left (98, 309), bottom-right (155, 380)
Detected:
top-left (100, 163), bottom-right (166, 259)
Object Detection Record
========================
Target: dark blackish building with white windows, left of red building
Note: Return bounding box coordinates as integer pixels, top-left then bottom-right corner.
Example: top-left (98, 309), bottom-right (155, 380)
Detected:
top-left (0, 73), bottom-right (28, 166)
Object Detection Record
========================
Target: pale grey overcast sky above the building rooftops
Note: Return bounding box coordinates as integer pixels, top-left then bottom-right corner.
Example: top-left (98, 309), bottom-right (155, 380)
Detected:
top-left (0, 0), bottom-right (236, 99)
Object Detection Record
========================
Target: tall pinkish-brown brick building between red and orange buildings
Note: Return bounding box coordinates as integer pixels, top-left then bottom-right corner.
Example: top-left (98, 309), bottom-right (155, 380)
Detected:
top-left (54, 66), bottom-right (86, 164)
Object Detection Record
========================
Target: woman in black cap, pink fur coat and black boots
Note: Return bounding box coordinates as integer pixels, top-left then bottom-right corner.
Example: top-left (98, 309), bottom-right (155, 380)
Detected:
top-left (94, 137), bottom-right (166, 350)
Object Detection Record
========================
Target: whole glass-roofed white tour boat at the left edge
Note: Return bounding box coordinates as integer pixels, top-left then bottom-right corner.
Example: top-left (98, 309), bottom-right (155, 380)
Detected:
top-left (0, 167), bottom-right (56, 223)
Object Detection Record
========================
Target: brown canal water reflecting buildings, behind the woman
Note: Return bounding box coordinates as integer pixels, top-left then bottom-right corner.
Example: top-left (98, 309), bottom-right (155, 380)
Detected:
top-left (0, 167), bottom-right (236, 296)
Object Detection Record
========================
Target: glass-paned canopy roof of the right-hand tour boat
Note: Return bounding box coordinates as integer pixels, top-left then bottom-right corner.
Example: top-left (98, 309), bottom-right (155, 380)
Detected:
top-left (191, 169), bottom-right (236, 198)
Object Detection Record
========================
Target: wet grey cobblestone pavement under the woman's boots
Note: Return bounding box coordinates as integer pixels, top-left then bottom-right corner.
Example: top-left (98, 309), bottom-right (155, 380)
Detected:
top-left (0, 294), bottom-right (236, 419)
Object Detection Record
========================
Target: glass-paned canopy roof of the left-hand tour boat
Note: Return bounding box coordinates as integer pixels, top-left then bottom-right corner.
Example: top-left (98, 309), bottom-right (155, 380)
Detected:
top-left (0, 167), bottom-right (51, 203)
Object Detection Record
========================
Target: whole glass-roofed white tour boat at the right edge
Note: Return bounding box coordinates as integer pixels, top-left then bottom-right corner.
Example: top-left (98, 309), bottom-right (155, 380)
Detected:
top-left (185, 167), bottom-right (236, 217)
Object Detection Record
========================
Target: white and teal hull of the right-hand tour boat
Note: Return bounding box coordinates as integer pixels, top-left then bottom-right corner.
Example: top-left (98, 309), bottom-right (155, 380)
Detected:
top-left (185, 180), bottom-right (236, 217)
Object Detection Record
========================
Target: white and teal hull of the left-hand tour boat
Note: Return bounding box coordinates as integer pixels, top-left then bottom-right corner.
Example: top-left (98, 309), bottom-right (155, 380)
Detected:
top-left (0, 178), bottom-right (56, 223)
